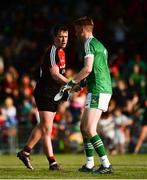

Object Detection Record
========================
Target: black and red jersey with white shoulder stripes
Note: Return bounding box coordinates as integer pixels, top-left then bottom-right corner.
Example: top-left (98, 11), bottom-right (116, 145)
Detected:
top-left (35, 45), bottom-right (66, 94)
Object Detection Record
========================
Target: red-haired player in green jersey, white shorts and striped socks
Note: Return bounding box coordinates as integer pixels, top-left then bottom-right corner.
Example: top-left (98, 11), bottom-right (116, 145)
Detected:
top-left (63, 17), bottom-right (112, 174)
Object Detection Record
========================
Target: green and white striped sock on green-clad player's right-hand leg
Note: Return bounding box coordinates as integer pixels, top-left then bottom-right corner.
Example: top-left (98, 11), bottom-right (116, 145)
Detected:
top-left (90, 134), bottom-right (110, 167)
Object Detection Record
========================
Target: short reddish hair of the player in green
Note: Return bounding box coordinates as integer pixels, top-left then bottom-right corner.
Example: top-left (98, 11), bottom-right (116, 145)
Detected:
top-left (74, 16), bottom-right (94, 30)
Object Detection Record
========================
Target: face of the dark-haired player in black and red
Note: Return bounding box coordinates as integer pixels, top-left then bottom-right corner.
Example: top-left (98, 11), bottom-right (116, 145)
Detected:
top-left (55, 31), bottom-right (68, 48)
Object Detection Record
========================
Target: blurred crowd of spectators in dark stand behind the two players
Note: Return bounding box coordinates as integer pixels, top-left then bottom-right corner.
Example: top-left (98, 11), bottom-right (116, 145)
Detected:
top-left (0, 0), bottom-right (147, 154)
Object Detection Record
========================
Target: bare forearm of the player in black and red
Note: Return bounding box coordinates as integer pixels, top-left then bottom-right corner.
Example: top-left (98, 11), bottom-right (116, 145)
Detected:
top-left (50, 64), bottom-right (69, 85)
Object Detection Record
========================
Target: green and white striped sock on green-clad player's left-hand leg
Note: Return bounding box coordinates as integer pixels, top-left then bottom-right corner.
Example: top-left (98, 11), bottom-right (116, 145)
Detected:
top-left (84, 139), bottom-right (94, 169)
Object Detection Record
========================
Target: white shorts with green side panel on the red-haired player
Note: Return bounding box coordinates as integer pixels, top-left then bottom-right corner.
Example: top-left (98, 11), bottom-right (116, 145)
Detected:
top-left (85, 93), bottom-right (111, 111)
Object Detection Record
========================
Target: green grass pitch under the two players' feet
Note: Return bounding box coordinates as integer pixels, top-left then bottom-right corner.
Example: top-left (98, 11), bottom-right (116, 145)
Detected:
top-left (0, 154), bottom-right (147, 179)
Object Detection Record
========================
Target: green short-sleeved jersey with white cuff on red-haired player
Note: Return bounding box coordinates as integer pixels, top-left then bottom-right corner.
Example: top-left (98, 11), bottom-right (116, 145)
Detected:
top-left (84, 36), bottom-right (112, 94)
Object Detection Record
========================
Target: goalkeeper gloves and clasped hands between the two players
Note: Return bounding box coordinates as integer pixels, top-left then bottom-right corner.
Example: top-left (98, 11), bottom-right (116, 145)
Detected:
top-left (54, 80), bottom-right (81, 101)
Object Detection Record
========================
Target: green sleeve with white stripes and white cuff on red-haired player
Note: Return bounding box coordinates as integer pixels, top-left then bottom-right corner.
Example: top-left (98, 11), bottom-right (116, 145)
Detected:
top-left (84, 40), bottom-right (95, 58)
